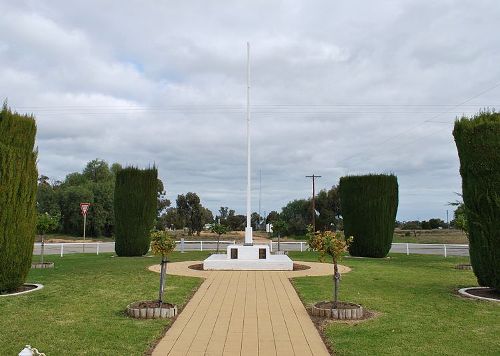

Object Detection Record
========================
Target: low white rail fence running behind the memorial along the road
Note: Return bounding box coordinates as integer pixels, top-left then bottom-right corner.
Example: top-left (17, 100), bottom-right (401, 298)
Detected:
top-left (33, 240), bottom-right (469, 257)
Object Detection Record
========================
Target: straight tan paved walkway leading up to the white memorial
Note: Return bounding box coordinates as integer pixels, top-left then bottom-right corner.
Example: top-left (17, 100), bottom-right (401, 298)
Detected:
top-left (151, 262), bottom-right (338, 356)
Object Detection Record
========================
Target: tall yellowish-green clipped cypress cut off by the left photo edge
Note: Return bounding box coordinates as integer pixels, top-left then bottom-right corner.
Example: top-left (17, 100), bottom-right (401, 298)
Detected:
top-left (0, 104), bottom-right (38, 292)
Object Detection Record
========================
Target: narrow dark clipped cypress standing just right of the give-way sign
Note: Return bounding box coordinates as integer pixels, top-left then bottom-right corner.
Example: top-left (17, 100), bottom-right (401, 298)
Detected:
top-left (114, 167), bottom-right (158, 256)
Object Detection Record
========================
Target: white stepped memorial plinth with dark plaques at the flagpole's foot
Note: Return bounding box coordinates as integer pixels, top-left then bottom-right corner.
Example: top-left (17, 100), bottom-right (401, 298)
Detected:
top-left (203, 245), bottom-right (293, 271)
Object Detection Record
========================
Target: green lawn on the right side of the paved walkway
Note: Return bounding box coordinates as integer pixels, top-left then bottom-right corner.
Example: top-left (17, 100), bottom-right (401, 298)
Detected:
top-left (289, 252), bottom-right (500, 355)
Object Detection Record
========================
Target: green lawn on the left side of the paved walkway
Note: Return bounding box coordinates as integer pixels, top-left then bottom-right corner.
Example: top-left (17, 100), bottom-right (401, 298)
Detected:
top-left (0, 252), bottom-right (208, 355)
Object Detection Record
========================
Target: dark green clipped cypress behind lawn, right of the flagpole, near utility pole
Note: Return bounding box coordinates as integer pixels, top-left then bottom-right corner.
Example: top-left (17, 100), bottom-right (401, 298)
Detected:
top-left (339, 174), bottom-right (398, 257)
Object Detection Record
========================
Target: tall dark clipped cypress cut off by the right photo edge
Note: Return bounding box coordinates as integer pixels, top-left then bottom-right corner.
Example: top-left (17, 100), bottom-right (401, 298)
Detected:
top-left (453, 112), bottom-right (500, 290)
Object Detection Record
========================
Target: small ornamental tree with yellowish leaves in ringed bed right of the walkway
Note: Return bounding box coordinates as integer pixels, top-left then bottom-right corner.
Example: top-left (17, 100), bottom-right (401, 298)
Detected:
top-left (307, 227), bottom-right (353, 309)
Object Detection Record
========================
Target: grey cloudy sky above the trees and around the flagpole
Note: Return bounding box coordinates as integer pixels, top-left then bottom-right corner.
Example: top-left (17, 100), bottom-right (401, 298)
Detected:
top-left (0, 0), bottom-right (500, 220)
